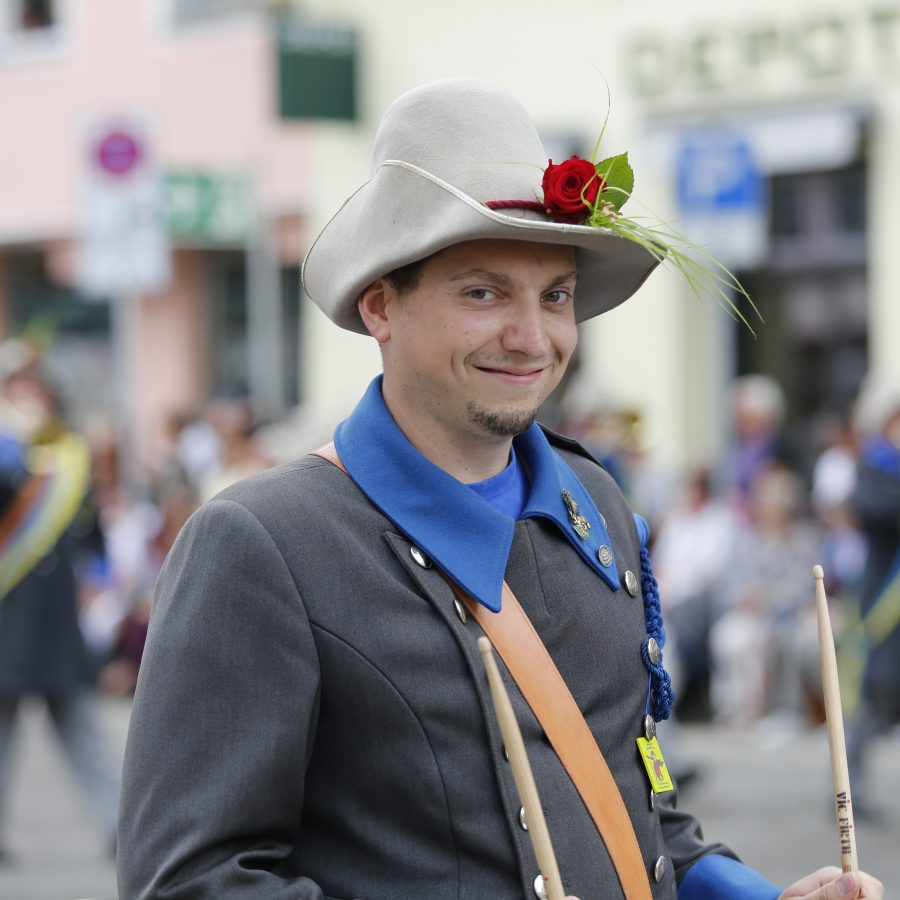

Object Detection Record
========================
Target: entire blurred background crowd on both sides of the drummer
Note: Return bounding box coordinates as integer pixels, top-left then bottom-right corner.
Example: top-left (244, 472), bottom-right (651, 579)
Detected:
top-left (0, 341), bottom-right (900, 860)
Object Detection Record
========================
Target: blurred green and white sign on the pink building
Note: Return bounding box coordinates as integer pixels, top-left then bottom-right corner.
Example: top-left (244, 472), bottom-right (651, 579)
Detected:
top-left (165, 170), bottom-right (253, 244)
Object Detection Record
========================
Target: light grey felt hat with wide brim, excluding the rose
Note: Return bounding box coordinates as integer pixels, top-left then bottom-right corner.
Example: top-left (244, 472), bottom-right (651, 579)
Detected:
top-left (302, 78), bottom-right (658, 334)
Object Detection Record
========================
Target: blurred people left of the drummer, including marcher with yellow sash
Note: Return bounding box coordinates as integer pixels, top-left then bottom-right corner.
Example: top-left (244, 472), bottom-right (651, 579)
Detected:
top-left (0, 340), bottom-right (328, 864)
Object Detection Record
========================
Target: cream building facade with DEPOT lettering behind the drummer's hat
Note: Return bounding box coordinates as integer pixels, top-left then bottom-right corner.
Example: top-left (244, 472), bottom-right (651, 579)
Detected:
top-left (304, 0), bottom-right (900, 478)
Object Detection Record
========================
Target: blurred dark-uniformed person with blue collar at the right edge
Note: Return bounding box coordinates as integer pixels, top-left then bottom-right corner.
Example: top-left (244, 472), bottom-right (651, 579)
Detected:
top-left (847, 376), bottom-right (900, 818)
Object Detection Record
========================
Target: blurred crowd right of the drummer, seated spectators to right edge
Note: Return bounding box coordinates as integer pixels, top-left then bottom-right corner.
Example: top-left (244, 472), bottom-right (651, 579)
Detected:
top-left (562, 375), bottom-right (900, 816)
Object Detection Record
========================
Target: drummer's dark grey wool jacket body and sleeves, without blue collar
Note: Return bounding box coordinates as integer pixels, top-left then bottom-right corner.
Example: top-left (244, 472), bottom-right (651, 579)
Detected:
top-left (118, 445), bottom-right (730, 900)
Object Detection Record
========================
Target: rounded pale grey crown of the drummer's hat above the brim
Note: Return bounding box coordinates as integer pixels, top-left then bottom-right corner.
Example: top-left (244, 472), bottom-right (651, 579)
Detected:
top-left (372, 78), bottom-right (547, 203)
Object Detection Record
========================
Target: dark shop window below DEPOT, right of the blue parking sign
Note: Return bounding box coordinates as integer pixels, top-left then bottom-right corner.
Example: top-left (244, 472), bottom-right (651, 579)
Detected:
top-left (736, 163), bottom-right (869, 474)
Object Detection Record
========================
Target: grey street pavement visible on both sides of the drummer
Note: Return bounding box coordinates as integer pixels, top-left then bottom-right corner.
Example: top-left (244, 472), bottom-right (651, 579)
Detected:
top-left (0, 700), bottom-right (900, 900)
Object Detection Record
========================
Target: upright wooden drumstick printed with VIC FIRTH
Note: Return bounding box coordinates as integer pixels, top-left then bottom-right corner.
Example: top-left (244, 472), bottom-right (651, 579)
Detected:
top-left (813, 566), bottom-right (859, 872)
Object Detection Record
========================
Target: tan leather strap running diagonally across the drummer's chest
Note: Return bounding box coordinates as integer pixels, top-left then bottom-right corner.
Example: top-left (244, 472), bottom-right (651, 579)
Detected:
top-left (313, 443), bottom-right (652, 900)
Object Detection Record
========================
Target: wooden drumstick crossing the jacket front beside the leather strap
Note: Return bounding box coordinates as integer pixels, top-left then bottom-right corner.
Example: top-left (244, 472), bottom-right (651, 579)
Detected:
top-left (478, 637), bottom-right (565, 900)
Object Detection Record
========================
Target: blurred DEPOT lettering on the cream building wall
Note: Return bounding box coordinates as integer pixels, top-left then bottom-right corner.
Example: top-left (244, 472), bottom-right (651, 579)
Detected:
top-left (626, 5), bottom-right (900, 98)
